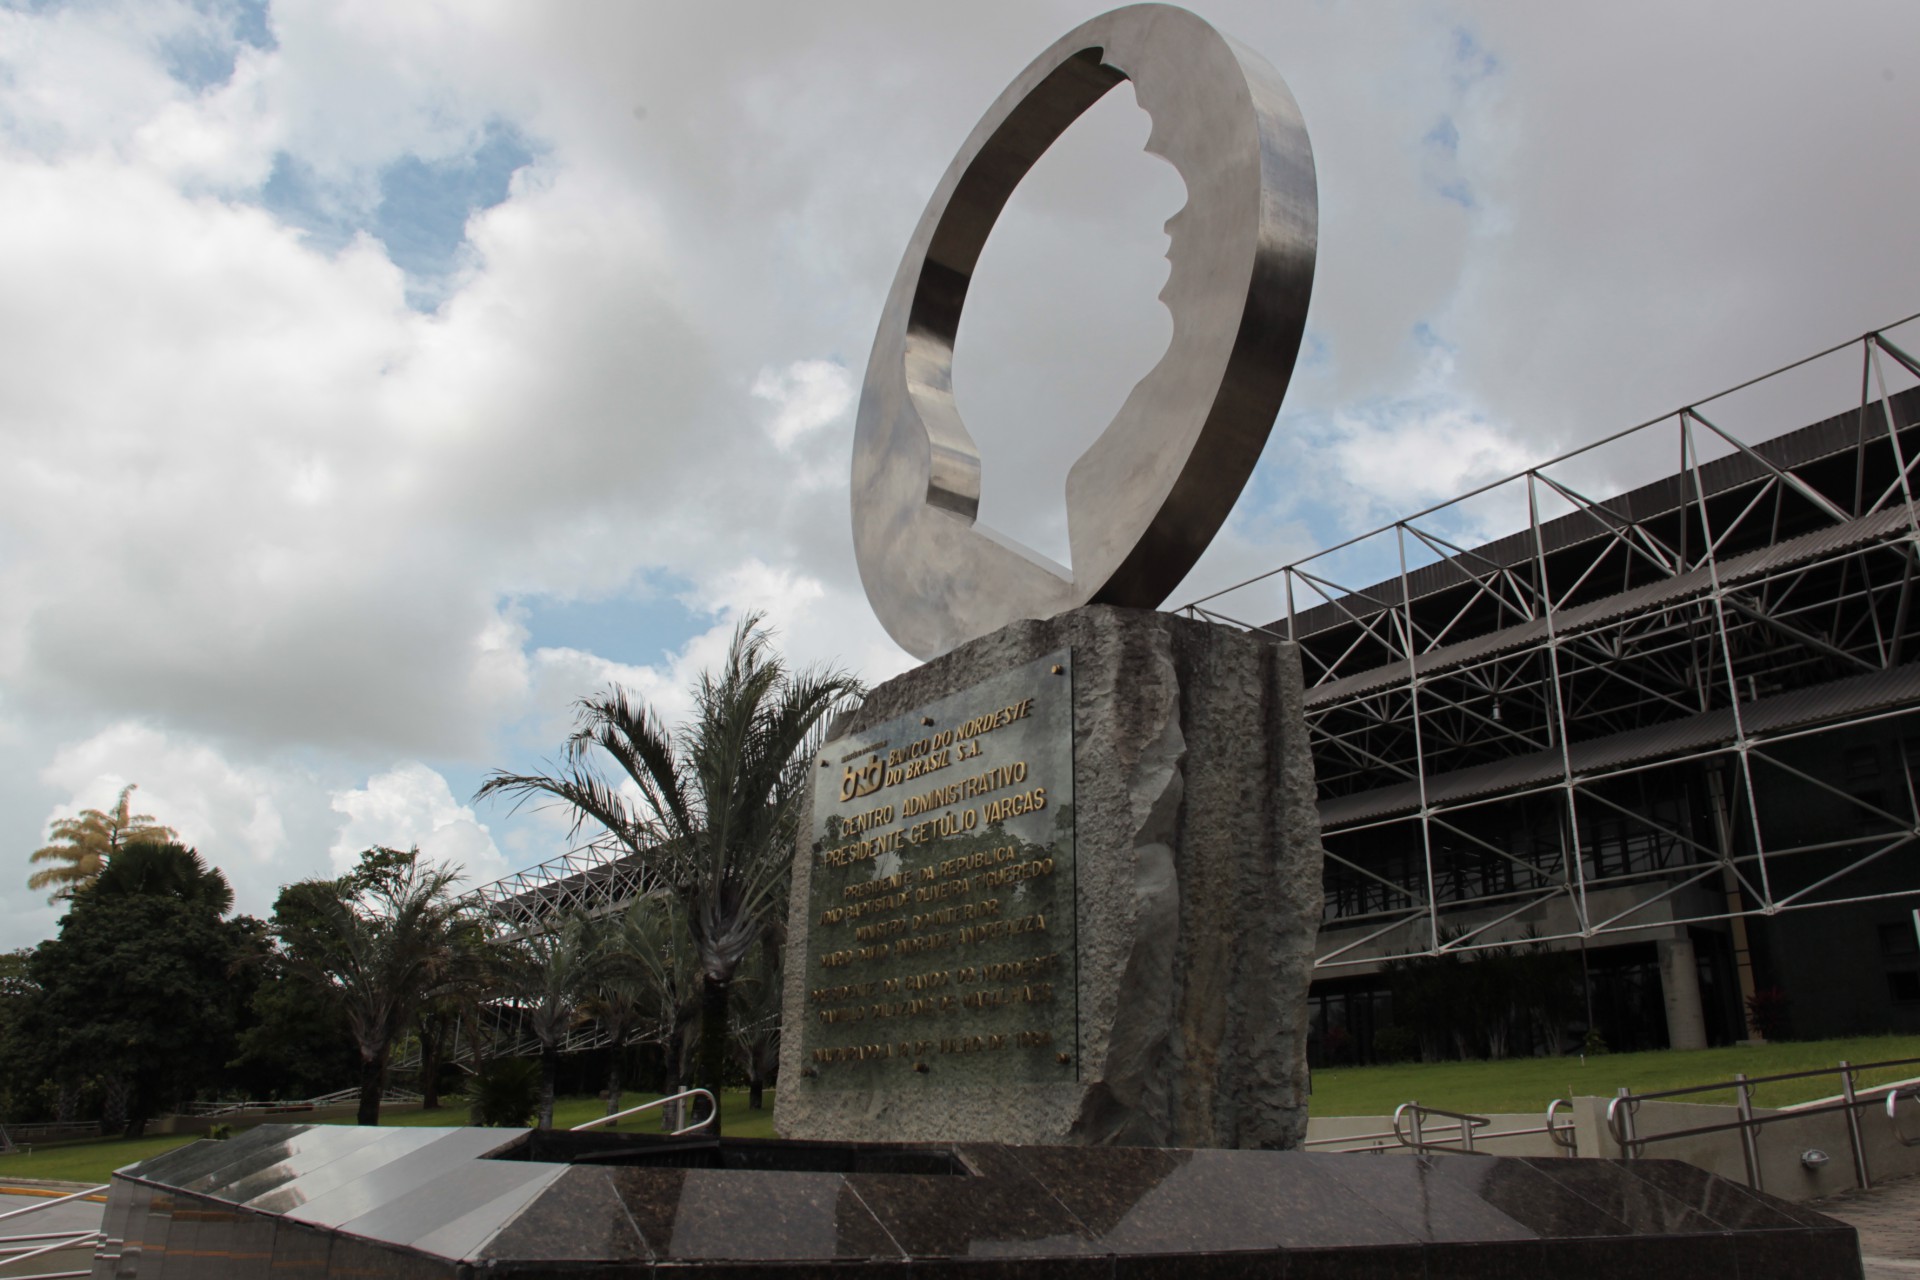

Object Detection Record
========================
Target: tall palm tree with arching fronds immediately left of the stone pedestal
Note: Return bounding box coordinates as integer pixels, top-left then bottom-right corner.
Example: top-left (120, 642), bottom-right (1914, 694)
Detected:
top-left (476, 614), bottom-right (860, 1132)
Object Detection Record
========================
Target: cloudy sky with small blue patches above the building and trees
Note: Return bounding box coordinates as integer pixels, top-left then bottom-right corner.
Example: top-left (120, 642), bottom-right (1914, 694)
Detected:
top-left (0, 0), bottom-right (1920, 946)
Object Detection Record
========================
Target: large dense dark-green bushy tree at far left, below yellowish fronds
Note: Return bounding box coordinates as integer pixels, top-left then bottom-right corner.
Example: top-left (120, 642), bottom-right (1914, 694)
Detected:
top-left (21, 844), bottom-right (265, 1136)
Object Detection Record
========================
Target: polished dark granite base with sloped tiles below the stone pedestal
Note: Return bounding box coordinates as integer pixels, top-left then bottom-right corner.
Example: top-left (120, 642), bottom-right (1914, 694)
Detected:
top-left (92, 1125), bottom-right (1860, 1280)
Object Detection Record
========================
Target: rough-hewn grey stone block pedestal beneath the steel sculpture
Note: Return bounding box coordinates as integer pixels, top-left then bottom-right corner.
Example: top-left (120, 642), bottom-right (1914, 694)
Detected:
top-left (774, 606), bottom-right (1321, 1148)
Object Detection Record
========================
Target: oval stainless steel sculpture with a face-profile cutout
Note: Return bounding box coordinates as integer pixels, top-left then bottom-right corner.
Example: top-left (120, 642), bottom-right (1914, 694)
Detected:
top-left (852, 4), bottom-right (1317, 658)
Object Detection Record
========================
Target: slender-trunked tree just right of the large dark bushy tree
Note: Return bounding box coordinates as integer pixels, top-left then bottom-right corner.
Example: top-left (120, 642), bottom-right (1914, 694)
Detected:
top-left (280, 848), bottom-right (463, 1125)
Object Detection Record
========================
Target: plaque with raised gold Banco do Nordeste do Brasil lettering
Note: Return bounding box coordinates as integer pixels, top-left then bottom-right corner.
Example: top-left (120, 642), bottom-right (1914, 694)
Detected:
top-left (789, 649), bottom-right (1079, 1088)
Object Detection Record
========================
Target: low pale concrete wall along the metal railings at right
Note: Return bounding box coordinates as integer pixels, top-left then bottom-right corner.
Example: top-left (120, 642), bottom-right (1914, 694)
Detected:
top-left (1308, 1098), bottom-right (1920, 1201)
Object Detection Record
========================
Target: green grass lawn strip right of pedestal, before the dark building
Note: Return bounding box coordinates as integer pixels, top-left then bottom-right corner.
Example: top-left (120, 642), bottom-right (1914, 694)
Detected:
top-left (1311, 1036), bottom-right (1920, 1115)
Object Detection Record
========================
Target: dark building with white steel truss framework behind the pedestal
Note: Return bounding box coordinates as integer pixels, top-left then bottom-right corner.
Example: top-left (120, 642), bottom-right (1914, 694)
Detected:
top-left (476, 317), bottom-right (1920, 1061)
